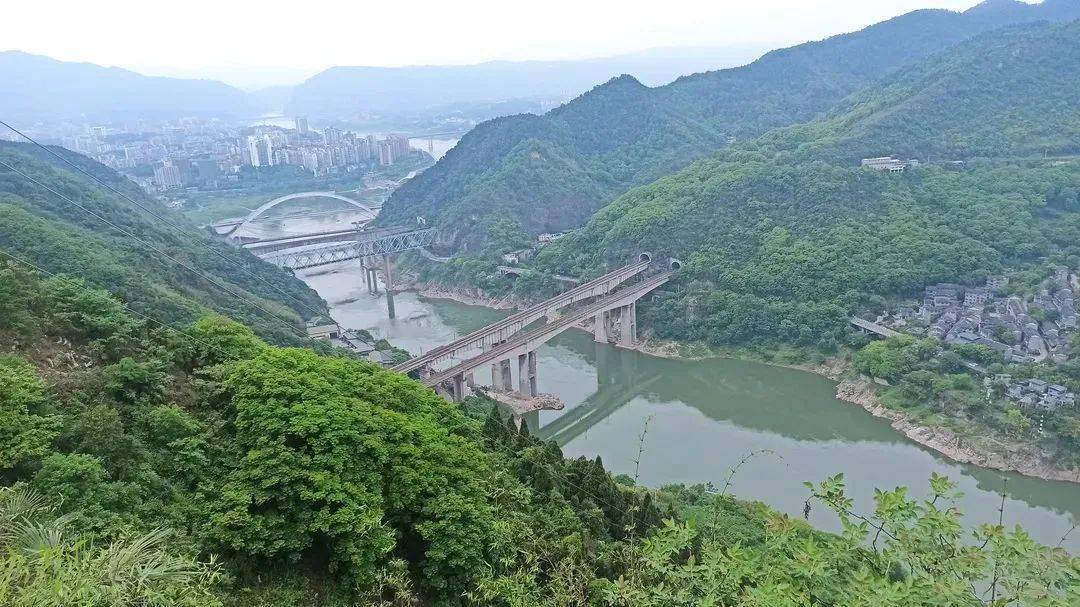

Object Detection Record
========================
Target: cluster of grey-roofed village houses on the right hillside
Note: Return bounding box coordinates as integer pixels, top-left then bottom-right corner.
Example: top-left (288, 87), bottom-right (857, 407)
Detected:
top-left (883, 267), bottom-right (1078, 364)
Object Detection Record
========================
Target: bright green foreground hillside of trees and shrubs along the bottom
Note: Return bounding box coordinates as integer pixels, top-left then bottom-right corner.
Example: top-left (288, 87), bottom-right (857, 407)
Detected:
top-left (0, 262), bottom-right (1080, 607)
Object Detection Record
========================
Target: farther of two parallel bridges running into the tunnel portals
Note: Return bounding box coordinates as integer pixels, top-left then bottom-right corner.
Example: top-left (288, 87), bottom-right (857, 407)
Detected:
top-left (392, 261), bottom-right (649, 373)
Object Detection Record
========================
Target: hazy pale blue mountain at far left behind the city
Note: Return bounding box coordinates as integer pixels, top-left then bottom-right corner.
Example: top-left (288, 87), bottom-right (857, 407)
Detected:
top-left (0, 51), bottom-right (255, 123)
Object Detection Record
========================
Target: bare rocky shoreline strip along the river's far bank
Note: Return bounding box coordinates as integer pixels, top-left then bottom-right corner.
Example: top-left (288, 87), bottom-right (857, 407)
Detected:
top-left (401, 284), bottom-right (1080, 484)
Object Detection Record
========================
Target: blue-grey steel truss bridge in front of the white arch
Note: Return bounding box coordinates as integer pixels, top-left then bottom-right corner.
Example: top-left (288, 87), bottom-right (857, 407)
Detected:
top-left (259, 228), bottom-right (436, 270)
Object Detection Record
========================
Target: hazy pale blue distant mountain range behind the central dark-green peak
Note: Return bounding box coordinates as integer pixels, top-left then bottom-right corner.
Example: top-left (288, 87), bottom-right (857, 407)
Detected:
top-left (286, 48), bottom-right (758, 120)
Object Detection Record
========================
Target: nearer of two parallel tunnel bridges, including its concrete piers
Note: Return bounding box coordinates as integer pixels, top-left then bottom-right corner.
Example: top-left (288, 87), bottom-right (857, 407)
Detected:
top-left (422, 271), bottom-right (672, 401)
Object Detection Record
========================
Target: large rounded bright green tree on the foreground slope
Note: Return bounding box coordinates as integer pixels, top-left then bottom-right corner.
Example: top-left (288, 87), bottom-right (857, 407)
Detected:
top-left (211, 349), bottom-right (492, 592)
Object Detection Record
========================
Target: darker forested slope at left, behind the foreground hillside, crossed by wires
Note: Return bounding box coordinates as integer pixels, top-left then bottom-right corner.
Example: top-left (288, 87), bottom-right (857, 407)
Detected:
top-left (0, 143), bottom-right (326, 343)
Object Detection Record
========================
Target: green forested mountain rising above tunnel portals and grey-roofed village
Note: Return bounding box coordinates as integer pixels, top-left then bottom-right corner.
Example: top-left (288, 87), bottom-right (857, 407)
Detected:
top-left (539, 22), bottom-right (1080, 345)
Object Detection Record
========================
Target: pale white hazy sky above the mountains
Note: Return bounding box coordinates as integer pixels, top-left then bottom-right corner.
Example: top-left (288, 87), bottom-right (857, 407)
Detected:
top-left (0, 0), bottom-right (1010, 76)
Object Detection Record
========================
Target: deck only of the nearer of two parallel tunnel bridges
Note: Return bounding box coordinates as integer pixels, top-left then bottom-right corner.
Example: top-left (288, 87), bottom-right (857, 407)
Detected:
top-left (419, 272), bottom-right (672, 387)
